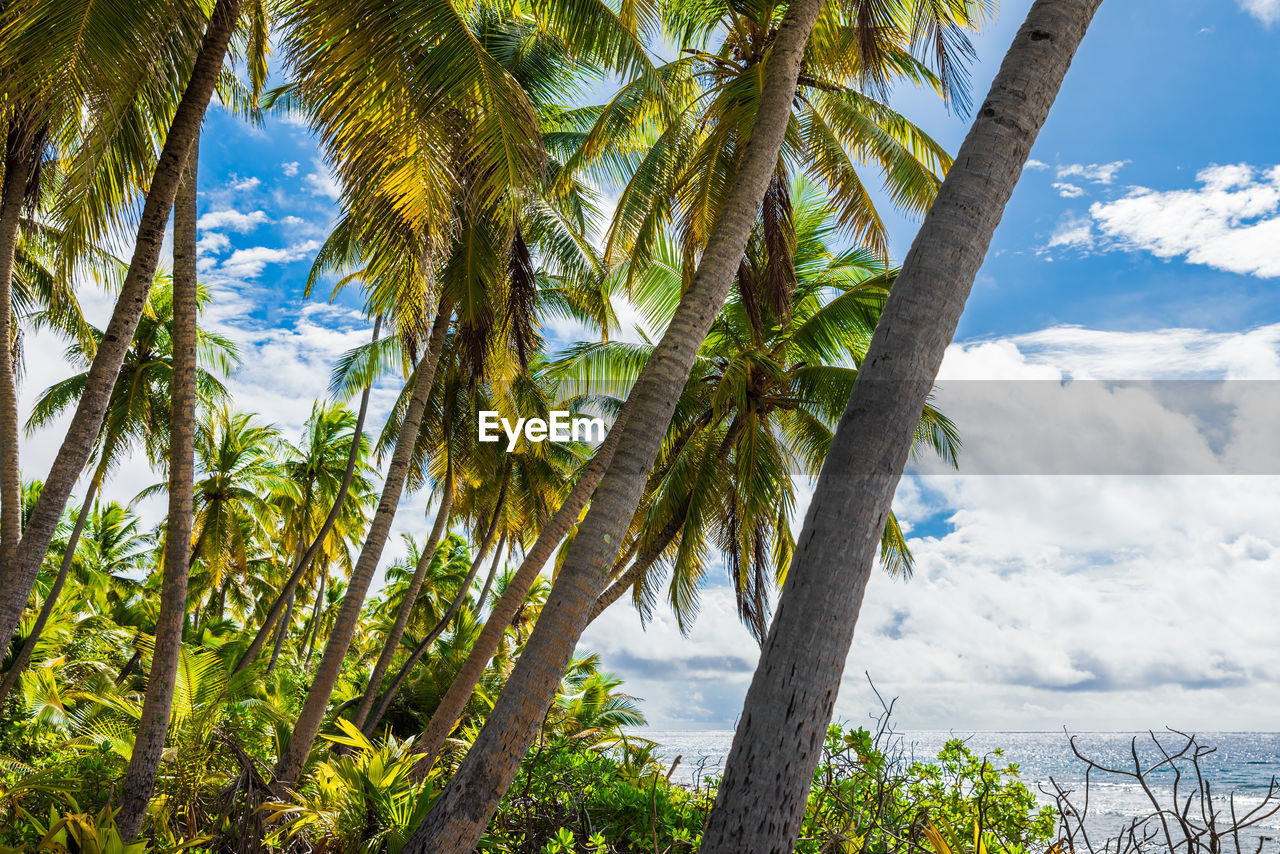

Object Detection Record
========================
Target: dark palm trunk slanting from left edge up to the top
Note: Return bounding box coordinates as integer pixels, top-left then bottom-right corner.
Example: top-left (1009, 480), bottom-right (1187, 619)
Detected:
top-left (0, 0), bottom-right (241, 660)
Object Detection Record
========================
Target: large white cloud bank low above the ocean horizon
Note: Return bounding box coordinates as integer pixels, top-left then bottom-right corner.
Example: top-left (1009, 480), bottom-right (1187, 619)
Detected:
top-left (584, 326), bottom-right (1280, 729)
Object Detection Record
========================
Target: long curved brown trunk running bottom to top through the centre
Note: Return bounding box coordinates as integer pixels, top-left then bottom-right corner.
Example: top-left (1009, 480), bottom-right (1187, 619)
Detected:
top-left (404, 0), bottom-right (822, 854)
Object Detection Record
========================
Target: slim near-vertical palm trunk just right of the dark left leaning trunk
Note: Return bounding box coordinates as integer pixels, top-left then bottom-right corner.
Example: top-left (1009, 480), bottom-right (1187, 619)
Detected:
top-left (116, 128), bottom-right (202, 842)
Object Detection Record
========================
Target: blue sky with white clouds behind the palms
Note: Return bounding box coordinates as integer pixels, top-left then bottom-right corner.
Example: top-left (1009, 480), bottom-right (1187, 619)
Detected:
top-left (22, 0), bottom-right (1280, 731)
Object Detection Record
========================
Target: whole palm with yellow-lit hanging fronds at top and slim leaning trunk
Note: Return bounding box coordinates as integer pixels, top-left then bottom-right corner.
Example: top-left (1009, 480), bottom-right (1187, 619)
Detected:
top-left (275, 3), bottom-right (643, 782)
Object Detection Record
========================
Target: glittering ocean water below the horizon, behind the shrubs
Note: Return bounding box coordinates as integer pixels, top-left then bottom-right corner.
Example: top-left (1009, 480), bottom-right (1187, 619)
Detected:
top-left (641, 730), bottom-right (1280, 853)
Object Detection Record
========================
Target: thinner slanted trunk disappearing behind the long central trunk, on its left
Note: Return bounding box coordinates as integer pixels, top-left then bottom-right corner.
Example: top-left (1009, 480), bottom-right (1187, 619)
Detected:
top-left (413, 405), bottom-right (630, 781)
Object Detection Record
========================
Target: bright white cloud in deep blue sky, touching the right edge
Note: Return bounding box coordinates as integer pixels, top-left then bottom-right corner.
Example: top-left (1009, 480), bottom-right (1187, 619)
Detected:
top-left (1080, 164), bottom-right (1280, 278)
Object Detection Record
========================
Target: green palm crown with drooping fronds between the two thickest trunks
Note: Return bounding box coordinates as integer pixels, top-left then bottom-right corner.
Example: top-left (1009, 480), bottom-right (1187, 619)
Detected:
top-left (573, 181), bottom-right (959, 643)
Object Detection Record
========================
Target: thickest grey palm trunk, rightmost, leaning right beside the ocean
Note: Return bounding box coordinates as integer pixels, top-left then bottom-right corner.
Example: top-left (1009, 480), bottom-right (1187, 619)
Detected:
top-left (701, 0), bottom-right (1101, 854)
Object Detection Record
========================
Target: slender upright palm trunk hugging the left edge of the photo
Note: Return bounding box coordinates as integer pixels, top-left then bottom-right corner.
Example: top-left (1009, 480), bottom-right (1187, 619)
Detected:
top-left (0, 128), bottom-right (31, 573)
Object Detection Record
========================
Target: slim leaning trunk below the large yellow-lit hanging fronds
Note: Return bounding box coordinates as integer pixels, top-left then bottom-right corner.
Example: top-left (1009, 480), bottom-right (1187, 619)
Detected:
top-left (275, 303), bottom-right (452, 785)
